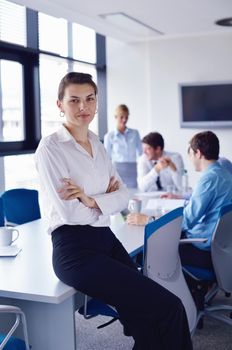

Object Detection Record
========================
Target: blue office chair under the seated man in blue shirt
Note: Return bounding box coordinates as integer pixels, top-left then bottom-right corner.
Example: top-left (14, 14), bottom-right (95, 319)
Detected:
top-left (183, 203), bottom-right (232, 328)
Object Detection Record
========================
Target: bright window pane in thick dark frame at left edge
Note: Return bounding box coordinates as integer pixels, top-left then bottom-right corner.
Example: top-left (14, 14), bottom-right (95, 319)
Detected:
top-left (0, 60), bottom-right (25, 141)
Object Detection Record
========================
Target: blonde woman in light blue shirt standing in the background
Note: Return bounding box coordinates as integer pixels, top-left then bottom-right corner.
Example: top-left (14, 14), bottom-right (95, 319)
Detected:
top-left (104, 104), bottom-right (143, 188)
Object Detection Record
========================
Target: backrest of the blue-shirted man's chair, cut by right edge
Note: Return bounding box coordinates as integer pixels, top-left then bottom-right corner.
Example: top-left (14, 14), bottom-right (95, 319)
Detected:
top-left (211, 203), bottom-right (232, 293)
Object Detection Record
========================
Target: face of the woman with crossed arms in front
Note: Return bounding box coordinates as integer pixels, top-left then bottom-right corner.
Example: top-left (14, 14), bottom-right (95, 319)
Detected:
top-left (57, 84), bottom-right (97, 127)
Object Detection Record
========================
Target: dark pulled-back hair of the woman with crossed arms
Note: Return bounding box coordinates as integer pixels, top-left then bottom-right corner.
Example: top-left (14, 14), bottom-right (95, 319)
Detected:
top-left (58, 72), bottom-right (97, 101)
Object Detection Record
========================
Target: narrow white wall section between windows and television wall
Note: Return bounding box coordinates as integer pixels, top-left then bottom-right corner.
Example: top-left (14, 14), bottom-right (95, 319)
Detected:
top-left (106, 39), bottom-right (150, 136)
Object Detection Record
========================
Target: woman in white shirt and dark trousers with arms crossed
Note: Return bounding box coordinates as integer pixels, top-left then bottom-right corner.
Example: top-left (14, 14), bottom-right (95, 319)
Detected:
top-left (36, 72), bottom-right (192, 350)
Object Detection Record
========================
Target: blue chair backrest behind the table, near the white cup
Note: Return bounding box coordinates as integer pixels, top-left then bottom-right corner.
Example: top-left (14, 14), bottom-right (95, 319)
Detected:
top-left (2, 188), bottom-right (41, 225)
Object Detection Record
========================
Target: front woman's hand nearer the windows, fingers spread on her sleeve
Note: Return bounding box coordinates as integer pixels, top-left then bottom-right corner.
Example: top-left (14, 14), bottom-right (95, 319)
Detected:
top-left (58, 177), bottom-right (99, 209)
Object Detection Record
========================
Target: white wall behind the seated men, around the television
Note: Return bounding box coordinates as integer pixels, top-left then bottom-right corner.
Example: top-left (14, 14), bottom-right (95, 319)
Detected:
top-left (107, 33), bottom-right (232, 186)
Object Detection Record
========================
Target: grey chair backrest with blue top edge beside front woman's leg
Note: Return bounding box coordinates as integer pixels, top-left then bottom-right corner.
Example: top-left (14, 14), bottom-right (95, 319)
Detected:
top-left (144, 208), bottom-right (197, 331)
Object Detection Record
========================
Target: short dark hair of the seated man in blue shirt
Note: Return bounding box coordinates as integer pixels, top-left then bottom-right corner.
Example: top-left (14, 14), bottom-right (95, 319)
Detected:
top-left (189, 131), bottom-right (220, 160)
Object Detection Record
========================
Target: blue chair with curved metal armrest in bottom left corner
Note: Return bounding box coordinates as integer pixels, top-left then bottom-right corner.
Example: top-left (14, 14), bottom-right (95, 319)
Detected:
top-left (0, 305), bottom-right (30, 350)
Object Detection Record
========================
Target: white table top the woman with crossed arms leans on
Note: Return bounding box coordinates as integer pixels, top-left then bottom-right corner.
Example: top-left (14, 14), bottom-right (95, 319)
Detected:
top-left (0, 218), bottom-right (143, 303)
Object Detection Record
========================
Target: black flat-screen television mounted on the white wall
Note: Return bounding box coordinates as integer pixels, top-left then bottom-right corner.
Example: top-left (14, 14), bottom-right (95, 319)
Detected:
top-left (179, 82), bottom-right (232, 129)
